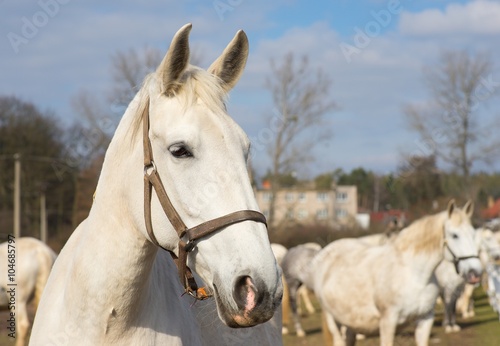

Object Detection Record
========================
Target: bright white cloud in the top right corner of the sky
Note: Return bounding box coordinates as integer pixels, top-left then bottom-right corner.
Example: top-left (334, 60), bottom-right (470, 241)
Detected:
top-left (399, 0), bottom-right (500, 36)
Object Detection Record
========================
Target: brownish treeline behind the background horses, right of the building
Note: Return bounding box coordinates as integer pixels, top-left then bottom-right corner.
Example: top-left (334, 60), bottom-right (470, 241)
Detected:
top-left (274, 155), bottom-right (500, 218)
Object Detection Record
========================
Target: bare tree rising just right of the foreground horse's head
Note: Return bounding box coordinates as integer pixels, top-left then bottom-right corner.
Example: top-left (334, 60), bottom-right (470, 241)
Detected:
top-left (266, 53), bottom-right (336, 225)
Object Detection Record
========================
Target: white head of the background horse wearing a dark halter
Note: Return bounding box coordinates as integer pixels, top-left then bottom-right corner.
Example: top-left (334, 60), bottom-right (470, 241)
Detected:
top-left (444, 200), bottom-right (482, 283)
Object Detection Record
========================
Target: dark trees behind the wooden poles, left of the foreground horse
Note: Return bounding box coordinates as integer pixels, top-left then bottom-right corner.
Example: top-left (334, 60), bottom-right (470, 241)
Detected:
top-left (0, 96), bottom-right (106, 246)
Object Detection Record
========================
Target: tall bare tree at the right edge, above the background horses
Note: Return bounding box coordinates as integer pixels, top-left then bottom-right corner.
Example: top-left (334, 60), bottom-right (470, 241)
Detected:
top-left (405, 51), bottom-right (500, 197)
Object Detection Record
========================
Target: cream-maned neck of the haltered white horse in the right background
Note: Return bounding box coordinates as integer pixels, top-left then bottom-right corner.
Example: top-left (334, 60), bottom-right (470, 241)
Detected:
top-left (394, 214), bottom-right (444, 278)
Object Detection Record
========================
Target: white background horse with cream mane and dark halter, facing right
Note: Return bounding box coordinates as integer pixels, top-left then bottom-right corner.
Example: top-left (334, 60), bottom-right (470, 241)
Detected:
top-left (312, 201), bottom-right (482, 346)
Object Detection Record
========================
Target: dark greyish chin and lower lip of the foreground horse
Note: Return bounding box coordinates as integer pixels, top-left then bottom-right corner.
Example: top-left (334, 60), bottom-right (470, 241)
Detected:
top-left (214, 285), bottom-right (274, 328)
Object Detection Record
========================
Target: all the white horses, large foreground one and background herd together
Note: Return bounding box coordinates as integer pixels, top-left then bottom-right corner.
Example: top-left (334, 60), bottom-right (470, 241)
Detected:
top-left (0, 24), bottom-right (500, 346)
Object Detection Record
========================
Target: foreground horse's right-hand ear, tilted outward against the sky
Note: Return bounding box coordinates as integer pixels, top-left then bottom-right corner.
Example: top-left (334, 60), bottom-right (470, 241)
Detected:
top-left (208, 30), bottom-right (249, 92)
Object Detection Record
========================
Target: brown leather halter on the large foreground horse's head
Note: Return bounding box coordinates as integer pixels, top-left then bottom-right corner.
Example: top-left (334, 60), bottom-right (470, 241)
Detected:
top-left (142, 99), bottom-right (267, 299)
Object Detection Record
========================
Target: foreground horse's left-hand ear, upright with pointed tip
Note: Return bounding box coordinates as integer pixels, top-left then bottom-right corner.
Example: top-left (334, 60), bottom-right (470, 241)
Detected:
top-left (156, 23), bottom-right (193, 95)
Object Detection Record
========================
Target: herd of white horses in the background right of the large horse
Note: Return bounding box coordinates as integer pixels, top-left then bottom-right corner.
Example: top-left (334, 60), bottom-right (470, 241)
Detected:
top-left (272, 201), bottom-right (500, 345)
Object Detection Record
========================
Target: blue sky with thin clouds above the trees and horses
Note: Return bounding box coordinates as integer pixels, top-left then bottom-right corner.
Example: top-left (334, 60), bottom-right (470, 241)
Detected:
top-left (0, 0), bottom-right (500, 177)
